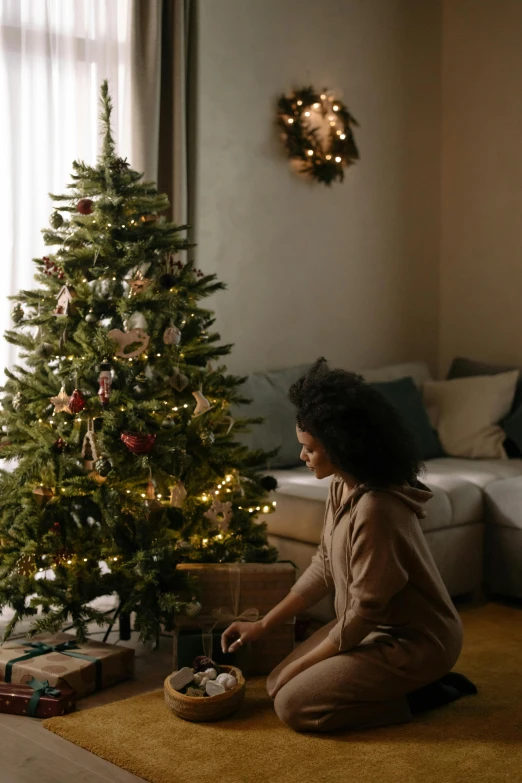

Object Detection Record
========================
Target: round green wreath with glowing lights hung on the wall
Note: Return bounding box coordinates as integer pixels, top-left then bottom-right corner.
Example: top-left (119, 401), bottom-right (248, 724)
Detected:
top-left (277, 87), bottom-right (359, 185)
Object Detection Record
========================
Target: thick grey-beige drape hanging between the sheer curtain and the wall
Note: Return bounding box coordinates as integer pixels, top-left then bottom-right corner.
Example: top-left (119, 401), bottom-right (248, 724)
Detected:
top-left (131, 0), bottom-right (197, 237)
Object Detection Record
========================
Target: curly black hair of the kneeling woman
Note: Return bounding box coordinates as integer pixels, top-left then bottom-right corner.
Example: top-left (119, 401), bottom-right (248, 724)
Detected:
top-left (288, 356), bottom-right (425, 486)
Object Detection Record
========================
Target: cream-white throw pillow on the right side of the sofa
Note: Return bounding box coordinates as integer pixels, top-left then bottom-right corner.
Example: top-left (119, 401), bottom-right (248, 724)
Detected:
top-left (422, 370), bottom-right (519, 459)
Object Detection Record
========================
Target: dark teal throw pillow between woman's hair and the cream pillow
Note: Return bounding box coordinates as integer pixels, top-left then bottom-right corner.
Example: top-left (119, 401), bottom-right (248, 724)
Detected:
top-left (369, 376), bottom-right (444, 459)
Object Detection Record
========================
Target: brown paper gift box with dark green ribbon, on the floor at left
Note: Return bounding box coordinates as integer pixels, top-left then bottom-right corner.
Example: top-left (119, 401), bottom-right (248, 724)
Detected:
top-left (0, 633), bottom-right (134, 699)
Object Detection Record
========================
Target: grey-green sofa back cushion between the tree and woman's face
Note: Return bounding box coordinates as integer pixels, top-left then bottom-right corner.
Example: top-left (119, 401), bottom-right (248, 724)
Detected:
top-left (230, 362), bottom-right (311, 469)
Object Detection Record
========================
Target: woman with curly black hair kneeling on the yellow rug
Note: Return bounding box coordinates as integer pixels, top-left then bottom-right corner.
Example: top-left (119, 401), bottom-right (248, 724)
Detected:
top-left (222, 358), bottom-right (477, 732)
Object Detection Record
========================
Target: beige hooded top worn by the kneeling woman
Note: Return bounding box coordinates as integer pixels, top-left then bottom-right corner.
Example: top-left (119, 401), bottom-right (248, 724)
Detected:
top-left (292, 476), bottom-right (463, 663)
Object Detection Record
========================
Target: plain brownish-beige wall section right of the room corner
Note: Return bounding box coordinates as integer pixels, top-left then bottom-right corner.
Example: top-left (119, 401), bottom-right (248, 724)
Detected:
top-left (440, 0), bottom-right (522, 380)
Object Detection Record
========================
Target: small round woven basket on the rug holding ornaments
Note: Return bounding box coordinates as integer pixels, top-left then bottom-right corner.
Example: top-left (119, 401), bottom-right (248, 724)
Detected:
top-left (164, 665), bottom-right (246, 723)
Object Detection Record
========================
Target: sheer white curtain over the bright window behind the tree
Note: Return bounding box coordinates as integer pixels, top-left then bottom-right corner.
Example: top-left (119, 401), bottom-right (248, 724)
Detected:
top-left (0, 0), bottom-right (132, 383)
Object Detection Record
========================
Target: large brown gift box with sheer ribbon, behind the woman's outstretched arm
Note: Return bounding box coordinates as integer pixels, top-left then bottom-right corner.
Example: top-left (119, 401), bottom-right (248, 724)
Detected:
top-left (174, 563), bottom-right (296, 674)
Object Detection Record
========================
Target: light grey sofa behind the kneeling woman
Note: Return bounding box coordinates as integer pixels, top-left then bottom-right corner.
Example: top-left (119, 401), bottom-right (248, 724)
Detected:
top-left (234, 362), bottom-right (522, 623)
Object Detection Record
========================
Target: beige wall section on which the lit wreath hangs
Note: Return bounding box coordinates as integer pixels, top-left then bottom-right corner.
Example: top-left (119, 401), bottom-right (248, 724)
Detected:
top-left (196, 0), bottom-right (438, 373)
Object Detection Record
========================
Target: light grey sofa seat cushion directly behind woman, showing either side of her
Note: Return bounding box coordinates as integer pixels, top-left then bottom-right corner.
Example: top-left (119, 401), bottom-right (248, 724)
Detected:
top-left (260, 460), bottom-right (483, 544)
